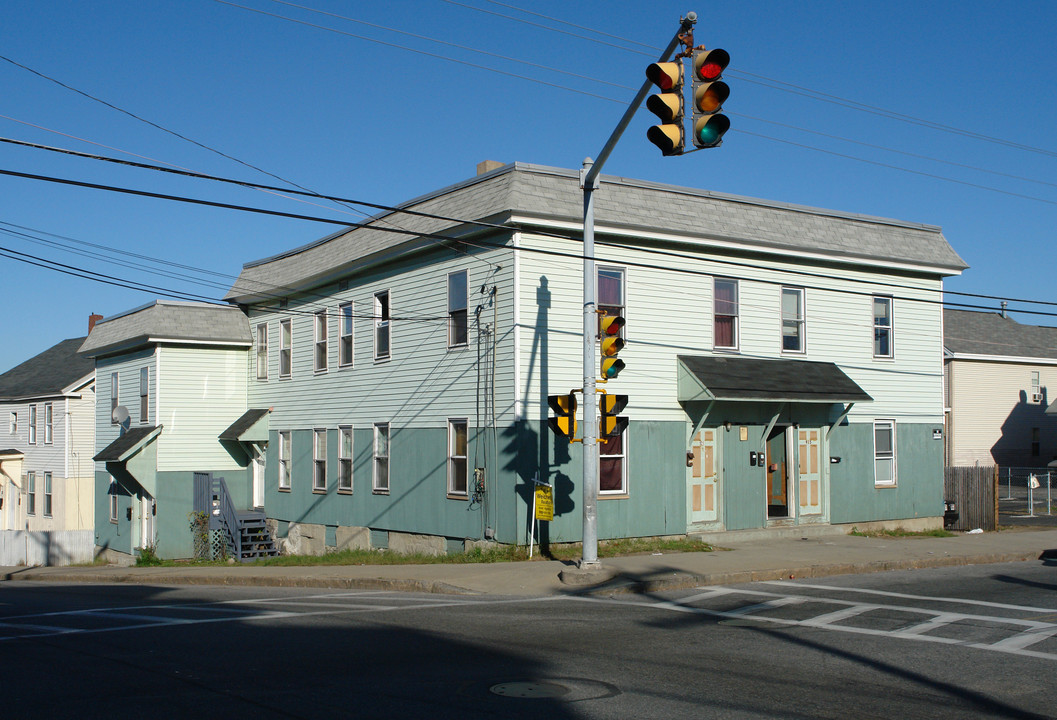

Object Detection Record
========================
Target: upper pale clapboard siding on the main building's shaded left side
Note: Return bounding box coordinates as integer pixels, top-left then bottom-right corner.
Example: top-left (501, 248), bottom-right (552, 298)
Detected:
top-left (245, 251), bottom-right (514, 429)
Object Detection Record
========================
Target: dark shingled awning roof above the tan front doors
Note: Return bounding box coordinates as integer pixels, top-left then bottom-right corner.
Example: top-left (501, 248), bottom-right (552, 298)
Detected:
top-left (678, 355), bottom-right (873, 403)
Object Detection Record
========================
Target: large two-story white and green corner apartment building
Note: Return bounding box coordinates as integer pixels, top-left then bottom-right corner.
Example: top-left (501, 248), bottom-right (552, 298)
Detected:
top-left (218, 164), bottom-right (966, 547)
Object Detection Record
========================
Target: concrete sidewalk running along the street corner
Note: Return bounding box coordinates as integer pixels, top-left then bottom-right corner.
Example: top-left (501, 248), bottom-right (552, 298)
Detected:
top-left (0, 529), bottom-right (1057, 596)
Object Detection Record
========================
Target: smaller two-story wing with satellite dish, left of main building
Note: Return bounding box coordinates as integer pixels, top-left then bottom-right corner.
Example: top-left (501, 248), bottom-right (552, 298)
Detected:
top-left (80, 300), bottom-right (251, 557)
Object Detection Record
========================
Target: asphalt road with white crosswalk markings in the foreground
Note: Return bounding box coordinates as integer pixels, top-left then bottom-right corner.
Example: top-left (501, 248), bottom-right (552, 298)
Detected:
top-left (0, 562), bottom-right (1057, 720)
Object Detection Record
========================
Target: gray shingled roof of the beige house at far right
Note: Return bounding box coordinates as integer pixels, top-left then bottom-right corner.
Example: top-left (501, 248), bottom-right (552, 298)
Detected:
top-left (943, 308), bottom-right (1057, 358)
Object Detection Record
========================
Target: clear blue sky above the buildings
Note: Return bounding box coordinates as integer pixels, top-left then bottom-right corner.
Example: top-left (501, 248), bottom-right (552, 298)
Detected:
top-left (0, 0), bottom-right (1057, 371)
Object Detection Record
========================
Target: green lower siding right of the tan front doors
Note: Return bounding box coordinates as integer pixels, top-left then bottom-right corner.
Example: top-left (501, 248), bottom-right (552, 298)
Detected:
top-left (830, 423), bottom-right (943, 523)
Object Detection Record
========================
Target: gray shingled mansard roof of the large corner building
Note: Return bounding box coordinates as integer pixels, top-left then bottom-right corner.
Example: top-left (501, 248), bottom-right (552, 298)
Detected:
top-left (225, 163), bottom-right (967, 301)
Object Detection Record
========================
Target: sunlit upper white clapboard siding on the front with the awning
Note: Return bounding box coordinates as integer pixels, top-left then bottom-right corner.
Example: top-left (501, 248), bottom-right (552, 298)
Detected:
top-left (518, 230), bottom-right (943, 422)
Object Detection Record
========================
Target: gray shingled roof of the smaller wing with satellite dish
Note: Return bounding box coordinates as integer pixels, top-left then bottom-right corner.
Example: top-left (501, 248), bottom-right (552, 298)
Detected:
top-left (80, 300), bottom-right (252, 357)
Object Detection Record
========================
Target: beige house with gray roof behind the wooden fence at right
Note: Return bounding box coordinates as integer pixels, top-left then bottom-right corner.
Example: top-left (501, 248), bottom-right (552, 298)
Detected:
top-left (943, 309), bottom-right (1057, 467)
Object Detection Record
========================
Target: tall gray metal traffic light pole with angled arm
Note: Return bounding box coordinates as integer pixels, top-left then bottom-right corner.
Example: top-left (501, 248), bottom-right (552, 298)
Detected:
top-left (580, 12), bottom-right (698, 570)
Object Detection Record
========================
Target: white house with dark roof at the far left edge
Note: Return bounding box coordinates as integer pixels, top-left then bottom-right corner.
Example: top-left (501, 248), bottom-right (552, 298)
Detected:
top-left (0, 337), bottom-right (95, 531)
